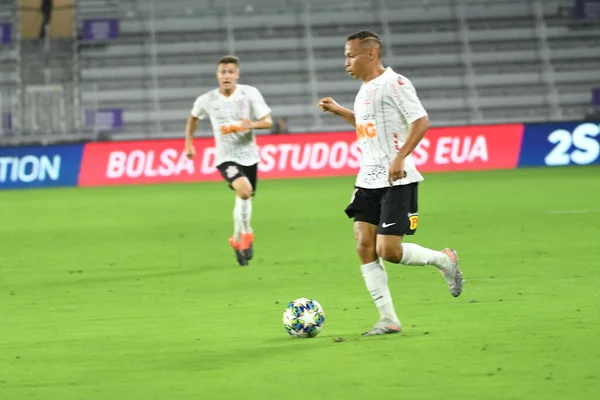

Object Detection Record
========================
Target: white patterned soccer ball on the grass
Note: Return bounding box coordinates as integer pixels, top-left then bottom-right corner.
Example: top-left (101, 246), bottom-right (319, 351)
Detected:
top-left (283, 297), bottom-right (325, 338)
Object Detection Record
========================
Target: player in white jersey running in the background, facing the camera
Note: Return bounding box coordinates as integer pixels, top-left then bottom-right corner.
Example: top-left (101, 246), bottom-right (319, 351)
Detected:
top-left (185, 56), bottom-right (273, 265)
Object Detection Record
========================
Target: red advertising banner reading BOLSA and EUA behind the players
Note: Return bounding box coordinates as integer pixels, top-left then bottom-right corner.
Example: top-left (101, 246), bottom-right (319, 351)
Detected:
top-left (79, 124), bottom-right (523, 186)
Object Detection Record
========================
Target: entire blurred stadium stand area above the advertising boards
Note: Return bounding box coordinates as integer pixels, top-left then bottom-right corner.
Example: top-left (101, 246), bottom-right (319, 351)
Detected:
top-left (0, 0), bottom-right (600, 145)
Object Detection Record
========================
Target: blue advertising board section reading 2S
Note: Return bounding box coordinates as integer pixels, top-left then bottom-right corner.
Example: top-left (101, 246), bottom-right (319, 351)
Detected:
top-left (519, 121), bottom-right (600, 167)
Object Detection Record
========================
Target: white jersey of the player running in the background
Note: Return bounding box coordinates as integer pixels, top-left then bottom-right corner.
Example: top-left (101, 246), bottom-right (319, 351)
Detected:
top-left (192, 85), bottom-right (271, 166)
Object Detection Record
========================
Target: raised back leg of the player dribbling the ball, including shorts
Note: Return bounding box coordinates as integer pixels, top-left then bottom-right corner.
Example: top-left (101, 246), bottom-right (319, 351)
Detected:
top-left (376, 183), bottom-right (463, 297)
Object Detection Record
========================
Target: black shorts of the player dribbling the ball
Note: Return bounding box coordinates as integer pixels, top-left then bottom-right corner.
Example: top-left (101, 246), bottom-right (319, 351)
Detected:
top-left (346, 182), bottom-right (419, 236)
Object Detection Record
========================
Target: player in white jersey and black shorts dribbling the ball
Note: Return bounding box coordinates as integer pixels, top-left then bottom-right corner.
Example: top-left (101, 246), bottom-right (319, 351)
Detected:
top-left (318, 31), bottom-right (463, 336)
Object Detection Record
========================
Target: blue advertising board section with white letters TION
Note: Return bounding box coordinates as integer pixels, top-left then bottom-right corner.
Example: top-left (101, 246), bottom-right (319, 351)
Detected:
top-left (0, 145), bottom-right (83, 190)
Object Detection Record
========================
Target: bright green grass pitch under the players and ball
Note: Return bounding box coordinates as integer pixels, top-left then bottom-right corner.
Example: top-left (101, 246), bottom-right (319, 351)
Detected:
top-left (0, 167), bottom-right (600, 400)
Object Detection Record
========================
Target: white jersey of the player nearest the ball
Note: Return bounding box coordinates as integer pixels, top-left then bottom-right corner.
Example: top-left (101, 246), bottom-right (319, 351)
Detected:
top-left (354, 67), bottom-right (427, 189)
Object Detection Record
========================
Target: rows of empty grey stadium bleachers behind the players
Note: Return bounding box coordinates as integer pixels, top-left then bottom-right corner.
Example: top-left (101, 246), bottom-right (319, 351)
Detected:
top-left (72, 0), bottom-right (600, 138)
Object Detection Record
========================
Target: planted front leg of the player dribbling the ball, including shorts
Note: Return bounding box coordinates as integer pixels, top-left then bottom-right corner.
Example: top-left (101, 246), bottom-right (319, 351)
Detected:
top-left (346, 189), bottom-right (401, 335)
